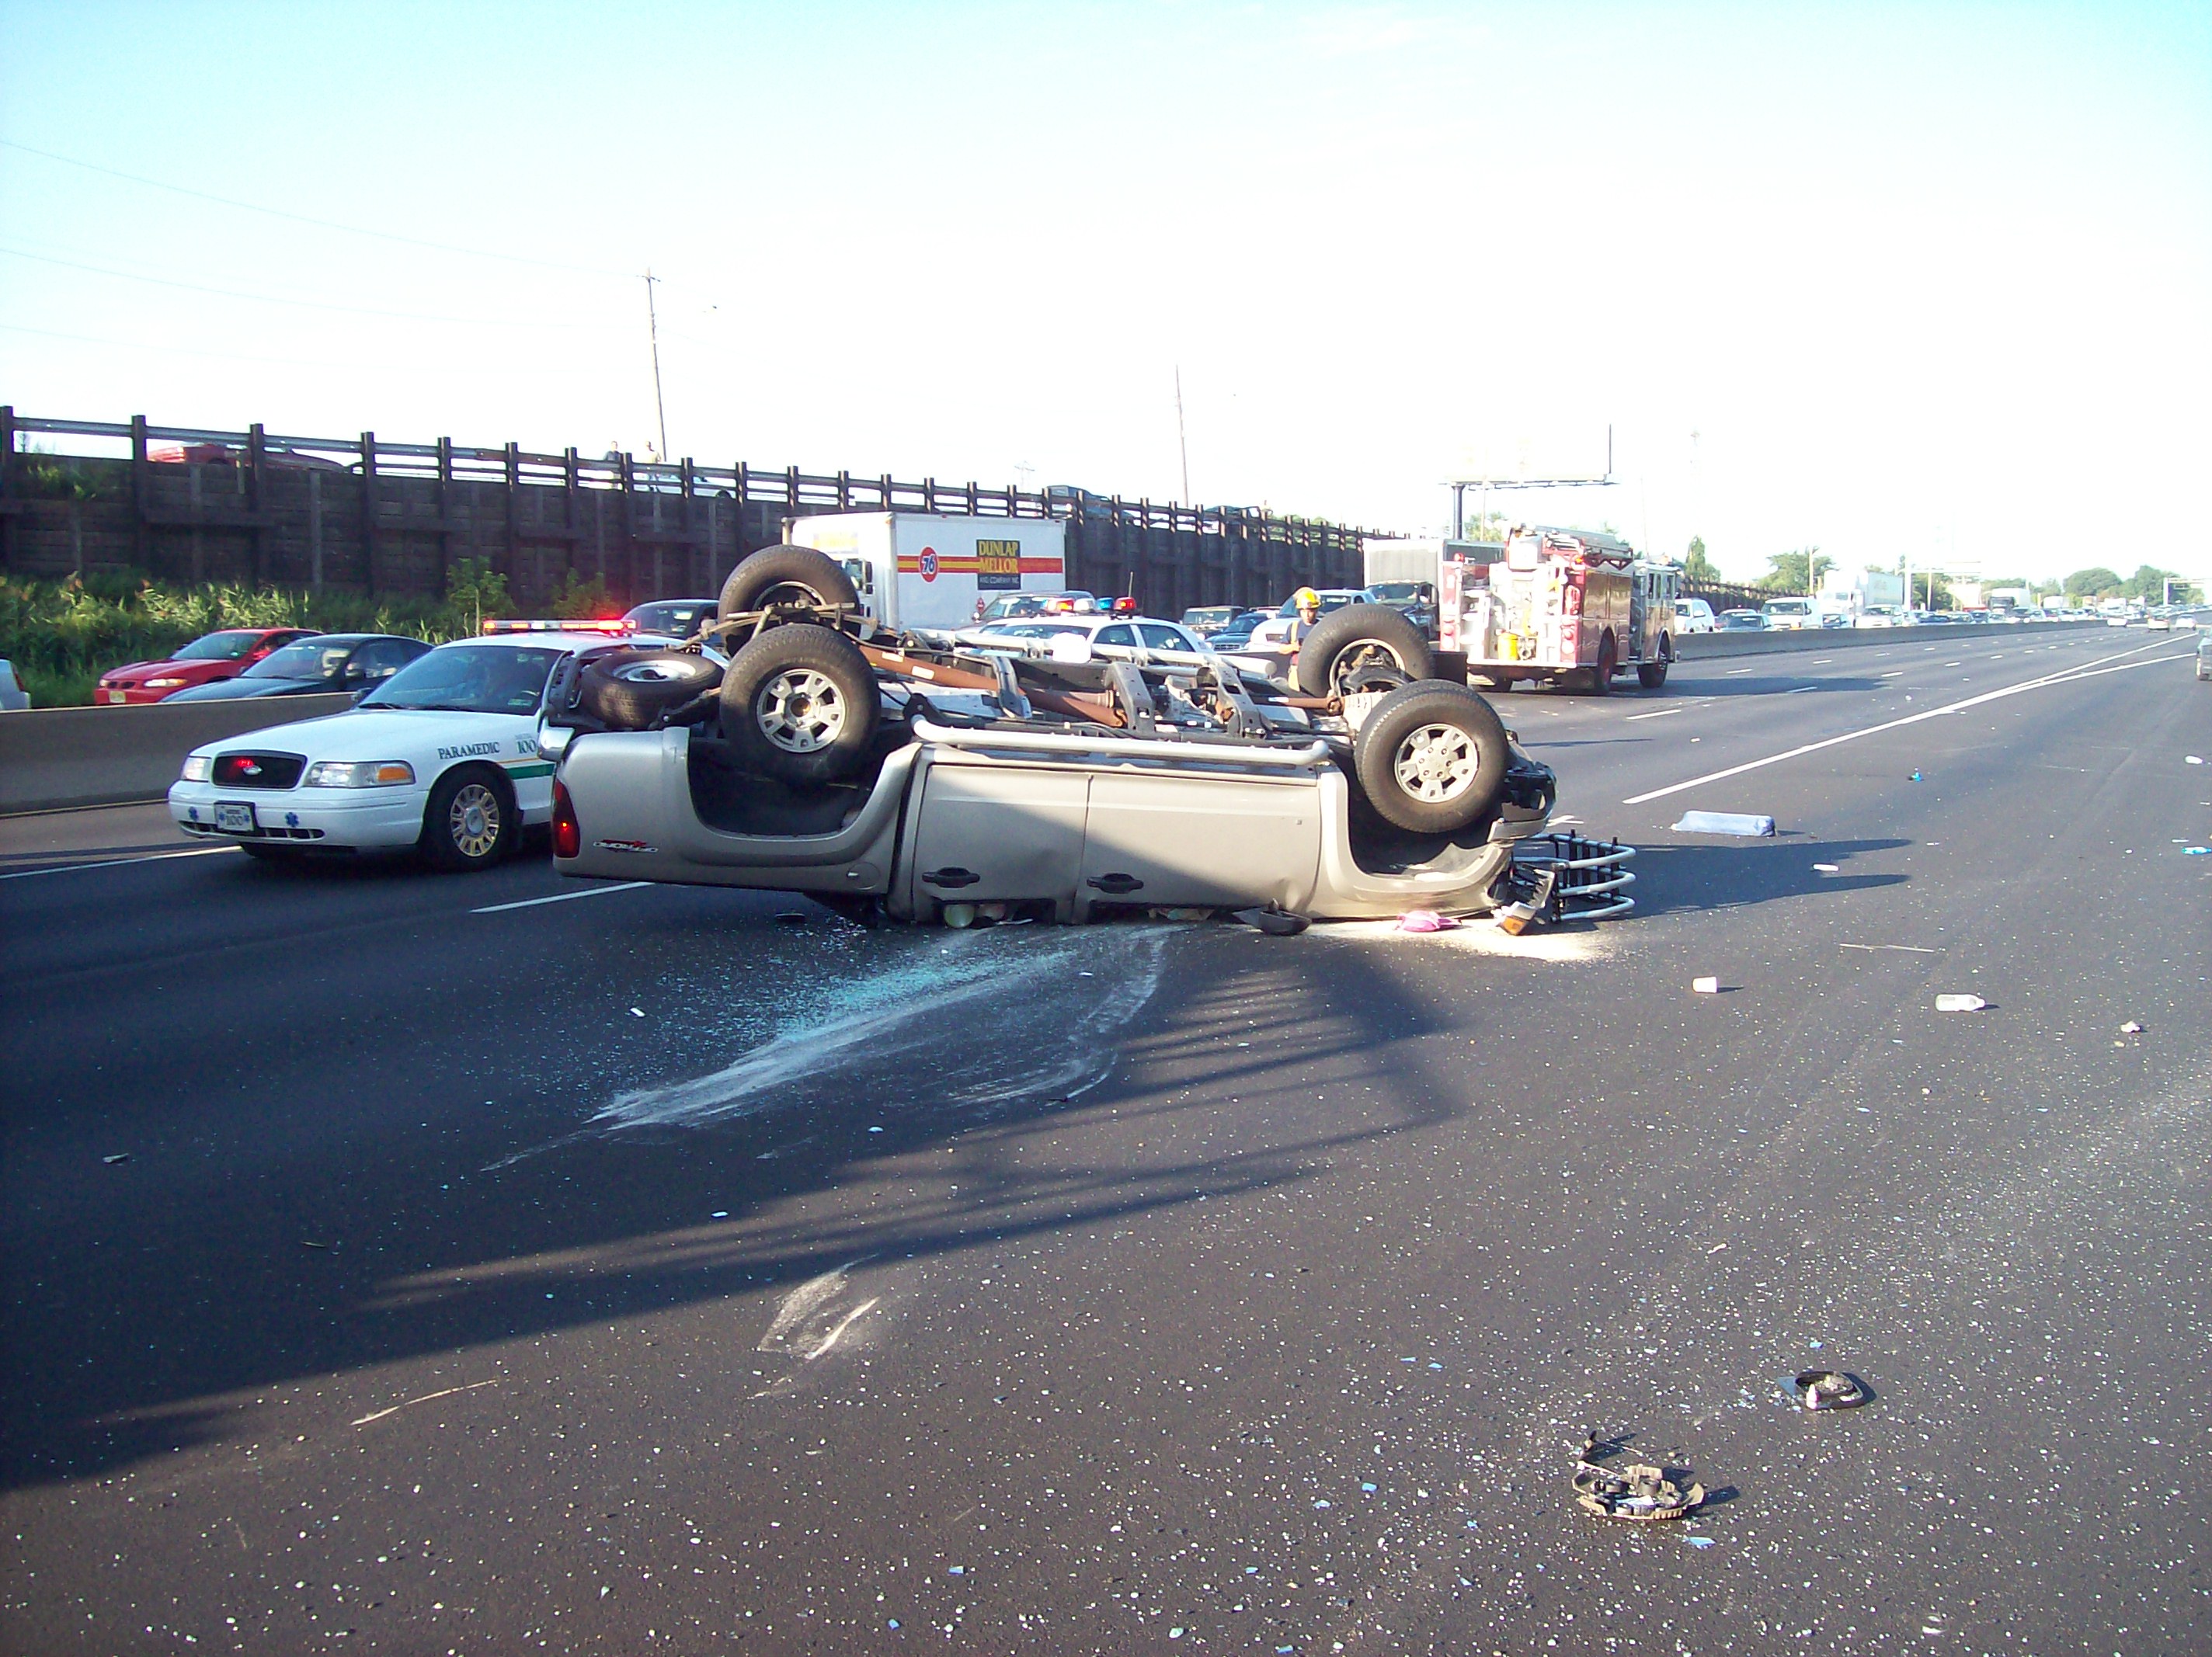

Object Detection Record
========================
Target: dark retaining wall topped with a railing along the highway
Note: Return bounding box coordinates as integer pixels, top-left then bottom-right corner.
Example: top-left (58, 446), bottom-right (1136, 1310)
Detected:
top-left (0, 407), bottom-right (1369, 609)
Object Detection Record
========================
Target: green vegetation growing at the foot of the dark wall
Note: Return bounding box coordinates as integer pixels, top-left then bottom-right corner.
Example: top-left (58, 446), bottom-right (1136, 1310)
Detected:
top-left (0, 560), bottom-right (513, 708)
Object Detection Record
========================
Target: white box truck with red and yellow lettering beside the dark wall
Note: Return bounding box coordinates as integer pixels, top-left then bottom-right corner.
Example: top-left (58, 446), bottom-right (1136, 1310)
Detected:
top-left (788, 511), bottom-right (1069, 630)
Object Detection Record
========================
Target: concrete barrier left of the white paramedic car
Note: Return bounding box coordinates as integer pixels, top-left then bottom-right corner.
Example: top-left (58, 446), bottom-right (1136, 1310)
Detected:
top-left (0, 695), bottom-right (354, 816)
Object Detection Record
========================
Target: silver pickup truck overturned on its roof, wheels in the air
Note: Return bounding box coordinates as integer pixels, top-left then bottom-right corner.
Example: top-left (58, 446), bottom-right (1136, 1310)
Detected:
top-left (542, 547), bottom-right (1633, 925)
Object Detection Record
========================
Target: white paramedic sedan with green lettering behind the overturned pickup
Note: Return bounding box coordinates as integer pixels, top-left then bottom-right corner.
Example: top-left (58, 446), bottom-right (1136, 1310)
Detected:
top-left (168, 622), bottom-right (659, 870)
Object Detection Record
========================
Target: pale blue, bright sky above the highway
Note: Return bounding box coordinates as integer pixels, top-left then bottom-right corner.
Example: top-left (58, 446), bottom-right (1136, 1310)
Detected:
top-left (0, 0), bottom-right (2212, 575)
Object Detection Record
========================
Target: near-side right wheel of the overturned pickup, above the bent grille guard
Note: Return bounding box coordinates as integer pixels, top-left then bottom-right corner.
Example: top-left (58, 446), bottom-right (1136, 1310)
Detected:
top-left (1351, 679), bottom-right (1511, 834)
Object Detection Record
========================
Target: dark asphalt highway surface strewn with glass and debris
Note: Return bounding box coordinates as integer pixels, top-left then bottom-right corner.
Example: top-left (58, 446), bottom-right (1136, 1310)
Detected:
top-left (0, 628), bottom-right (2212, 1657)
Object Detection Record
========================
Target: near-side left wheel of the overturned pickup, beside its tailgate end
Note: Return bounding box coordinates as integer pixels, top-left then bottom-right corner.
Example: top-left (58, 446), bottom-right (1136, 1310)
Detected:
top-left (721, 622), bottom-right (876, 783)
